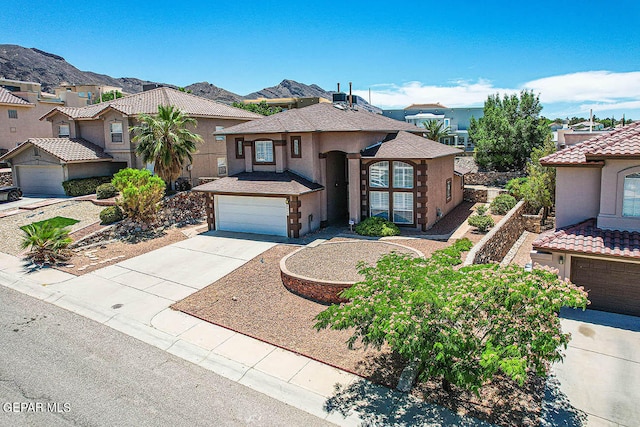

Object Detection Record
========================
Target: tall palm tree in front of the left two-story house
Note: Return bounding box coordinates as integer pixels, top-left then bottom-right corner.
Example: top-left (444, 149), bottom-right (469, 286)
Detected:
top-left (131, 105), bottom-right (202, 185)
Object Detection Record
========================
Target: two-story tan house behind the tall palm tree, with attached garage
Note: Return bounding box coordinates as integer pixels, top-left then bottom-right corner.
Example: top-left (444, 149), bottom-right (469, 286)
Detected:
top-left (0, 87), bottom-right (263, 194)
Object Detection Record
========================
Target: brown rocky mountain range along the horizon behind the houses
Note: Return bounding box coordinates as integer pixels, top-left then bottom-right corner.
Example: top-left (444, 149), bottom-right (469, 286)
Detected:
top-left (0, 44), bottom-right (381, 113)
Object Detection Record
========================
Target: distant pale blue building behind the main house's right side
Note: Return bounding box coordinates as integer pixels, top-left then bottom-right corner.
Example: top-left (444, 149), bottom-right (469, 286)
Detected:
top-left (382, 103), bottom-right (484, 151)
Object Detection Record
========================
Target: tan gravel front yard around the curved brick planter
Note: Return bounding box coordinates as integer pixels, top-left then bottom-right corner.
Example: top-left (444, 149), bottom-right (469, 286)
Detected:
top-left (172, 239), bottom-right (544, 426)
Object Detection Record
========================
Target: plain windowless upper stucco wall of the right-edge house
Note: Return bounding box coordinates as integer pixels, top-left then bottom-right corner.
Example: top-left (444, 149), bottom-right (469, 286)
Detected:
top-left (556, 167), bottom-right (601, 228)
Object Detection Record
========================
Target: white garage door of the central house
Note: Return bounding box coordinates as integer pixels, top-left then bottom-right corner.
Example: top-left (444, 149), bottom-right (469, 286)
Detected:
top-left (215, 195), bottom-right (289, 237)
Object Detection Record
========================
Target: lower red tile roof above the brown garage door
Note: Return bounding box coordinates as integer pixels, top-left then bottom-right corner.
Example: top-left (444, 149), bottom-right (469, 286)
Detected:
top-left (533, 219), bottom-right (640, 259)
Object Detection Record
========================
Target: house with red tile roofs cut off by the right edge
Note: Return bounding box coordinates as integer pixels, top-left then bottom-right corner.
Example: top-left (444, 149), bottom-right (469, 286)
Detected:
top-left (531, 123), bottom-right (640, 316)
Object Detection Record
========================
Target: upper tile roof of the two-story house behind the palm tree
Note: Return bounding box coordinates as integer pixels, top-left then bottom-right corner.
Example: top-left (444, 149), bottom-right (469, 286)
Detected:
top-left (43, 87), bottom-right (264, 120)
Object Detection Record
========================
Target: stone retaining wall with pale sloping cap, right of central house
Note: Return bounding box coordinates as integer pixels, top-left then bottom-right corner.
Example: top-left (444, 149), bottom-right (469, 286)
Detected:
top-left (465, 201), bottom-right (526, 265)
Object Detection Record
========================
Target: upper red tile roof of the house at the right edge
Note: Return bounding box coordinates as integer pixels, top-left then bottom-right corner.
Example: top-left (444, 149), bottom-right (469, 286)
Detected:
top-left (540, 122), bottom-right (640, 166)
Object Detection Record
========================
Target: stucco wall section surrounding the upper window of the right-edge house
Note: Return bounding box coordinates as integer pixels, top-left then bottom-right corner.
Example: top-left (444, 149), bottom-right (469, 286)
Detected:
top-left (598, 159), bottom-right (640, 231)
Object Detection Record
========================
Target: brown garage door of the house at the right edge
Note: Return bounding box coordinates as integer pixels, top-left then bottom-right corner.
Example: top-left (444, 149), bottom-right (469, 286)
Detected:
top-left (571, 257), bottom-right (640, 316)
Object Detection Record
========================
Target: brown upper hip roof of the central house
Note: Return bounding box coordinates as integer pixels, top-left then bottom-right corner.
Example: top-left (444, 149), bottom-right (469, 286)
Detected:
top-left (216, 102), bottom-right (424, 135)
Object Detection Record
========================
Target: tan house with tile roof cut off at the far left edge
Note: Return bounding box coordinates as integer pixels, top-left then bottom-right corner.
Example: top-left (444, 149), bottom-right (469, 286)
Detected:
top-left (0, 79), bottom-right (88, 155)
